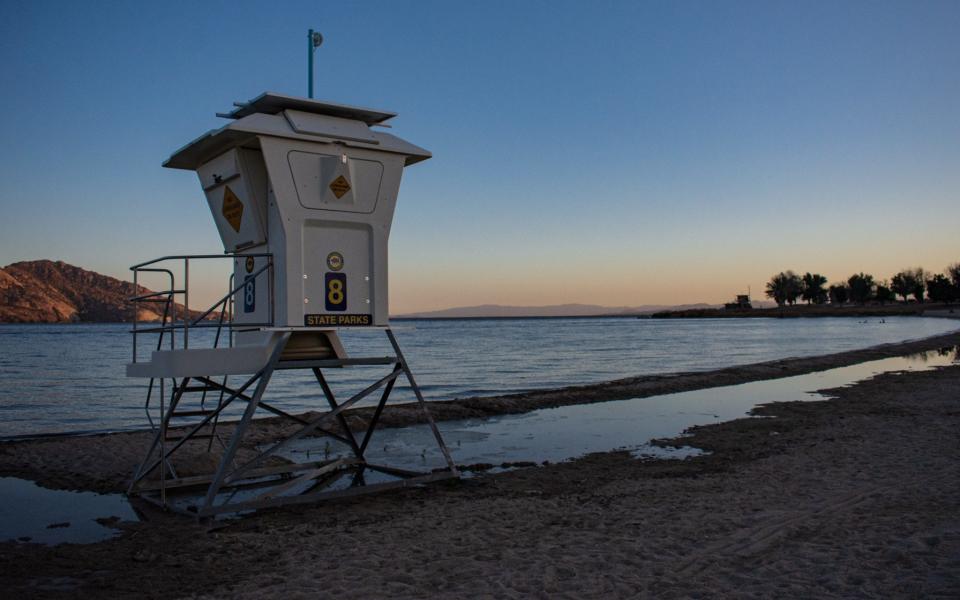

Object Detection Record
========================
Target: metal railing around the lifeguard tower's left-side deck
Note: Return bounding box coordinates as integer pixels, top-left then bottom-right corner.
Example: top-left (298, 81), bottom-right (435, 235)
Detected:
top-left (128, 253), bottom-right (274, 362)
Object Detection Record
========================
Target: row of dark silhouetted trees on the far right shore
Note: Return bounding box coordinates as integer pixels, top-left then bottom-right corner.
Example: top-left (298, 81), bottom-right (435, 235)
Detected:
top-left (766, 263), bottom-right (960, 306)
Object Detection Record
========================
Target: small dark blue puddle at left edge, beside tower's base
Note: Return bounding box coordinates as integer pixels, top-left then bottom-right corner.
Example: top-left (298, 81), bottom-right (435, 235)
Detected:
top-left (0, 477), bottom-right (139, 544)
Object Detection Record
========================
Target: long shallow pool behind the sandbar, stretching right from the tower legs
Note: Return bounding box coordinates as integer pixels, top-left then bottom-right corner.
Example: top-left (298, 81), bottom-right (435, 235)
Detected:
top-left (281, 349), bottom-right (957, 478)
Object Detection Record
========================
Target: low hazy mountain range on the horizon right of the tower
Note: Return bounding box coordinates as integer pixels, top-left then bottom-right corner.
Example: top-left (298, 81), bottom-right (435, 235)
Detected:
top-left (394, 304), bottom-right (718, 319)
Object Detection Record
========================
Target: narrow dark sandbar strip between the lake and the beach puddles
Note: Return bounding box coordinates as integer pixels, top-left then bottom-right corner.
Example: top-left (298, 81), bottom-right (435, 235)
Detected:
top-left (0, 331), bottom-right (960, 493)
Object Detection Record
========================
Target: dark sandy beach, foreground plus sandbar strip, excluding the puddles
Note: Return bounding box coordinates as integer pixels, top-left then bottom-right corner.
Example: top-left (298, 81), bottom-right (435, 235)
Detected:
top-left (0, 335), bottom-right (960, 598)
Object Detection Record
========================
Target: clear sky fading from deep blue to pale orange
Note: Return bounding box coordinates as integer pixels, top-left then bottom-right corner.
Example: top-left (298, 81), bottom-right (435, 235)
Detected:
top-left (0, 0), bottom-right (960, 314)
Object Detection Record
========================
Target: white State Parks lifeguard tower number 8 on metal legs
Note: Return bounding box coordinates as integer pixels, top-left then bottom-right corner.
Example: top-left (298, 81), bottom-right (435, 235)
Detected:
top-left (127, 93), bottom-right (458, 517)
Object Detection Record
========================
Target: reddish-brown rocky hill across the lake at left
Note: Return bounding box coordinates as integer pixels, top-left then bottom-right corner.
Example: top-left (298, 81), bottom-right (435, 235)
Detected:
top-left (0, 260), bottom-right (195, 323)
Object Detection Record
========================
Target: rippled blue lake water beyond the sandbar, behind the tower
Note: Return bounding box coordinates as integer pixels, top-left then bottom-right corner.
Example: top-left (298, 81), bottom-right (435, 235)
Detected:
top-left (0, 317), bottom-right (960, 436)
